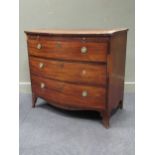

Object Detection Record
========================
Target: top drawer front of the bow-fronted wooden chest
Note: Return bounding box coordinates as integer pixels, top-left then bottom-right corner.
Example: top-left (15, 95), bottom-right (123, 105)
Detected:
top-left (28, 37), bottom-right (108, 62)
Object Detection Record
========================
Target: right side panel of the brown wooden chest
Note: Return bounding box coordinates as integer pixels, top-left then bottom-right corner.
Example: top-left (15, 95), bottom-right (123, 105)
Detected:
top-left (107, 32), bottom-right (127, 111)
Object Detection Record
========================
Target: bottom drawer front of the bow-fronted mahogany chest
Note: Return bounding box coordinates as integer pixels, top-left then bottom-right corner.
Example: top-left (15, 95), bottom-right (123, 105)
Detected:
top-left (31, 75), bottom-right (105, 108)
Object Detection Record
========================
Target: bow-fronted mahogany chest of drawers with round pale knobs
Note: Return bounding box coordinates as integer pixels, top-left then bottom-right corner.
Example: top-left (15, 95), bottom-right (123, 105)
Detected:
top-left (25, 29), bottom-right (127, 128)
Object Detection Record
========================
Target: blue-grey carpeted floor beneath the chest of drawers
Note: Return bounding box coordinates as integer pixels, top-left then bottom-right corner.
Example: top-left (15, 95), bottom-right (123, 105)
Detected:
top-left (19, 93), bottom-right (135, 155)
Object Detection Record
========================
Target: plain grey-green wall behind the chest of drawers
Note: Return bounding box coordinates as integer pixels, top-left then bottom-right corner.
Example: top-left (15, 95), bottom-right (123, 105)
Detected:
top-left (19, 0), bottom-right (135, 91)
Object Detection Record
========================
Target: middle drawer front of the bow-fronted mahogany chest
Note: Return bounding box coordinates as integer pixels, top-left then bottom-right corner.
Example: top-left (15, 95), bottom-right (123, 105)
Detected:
top-left (29, 57), bottom-right (106, 86)
